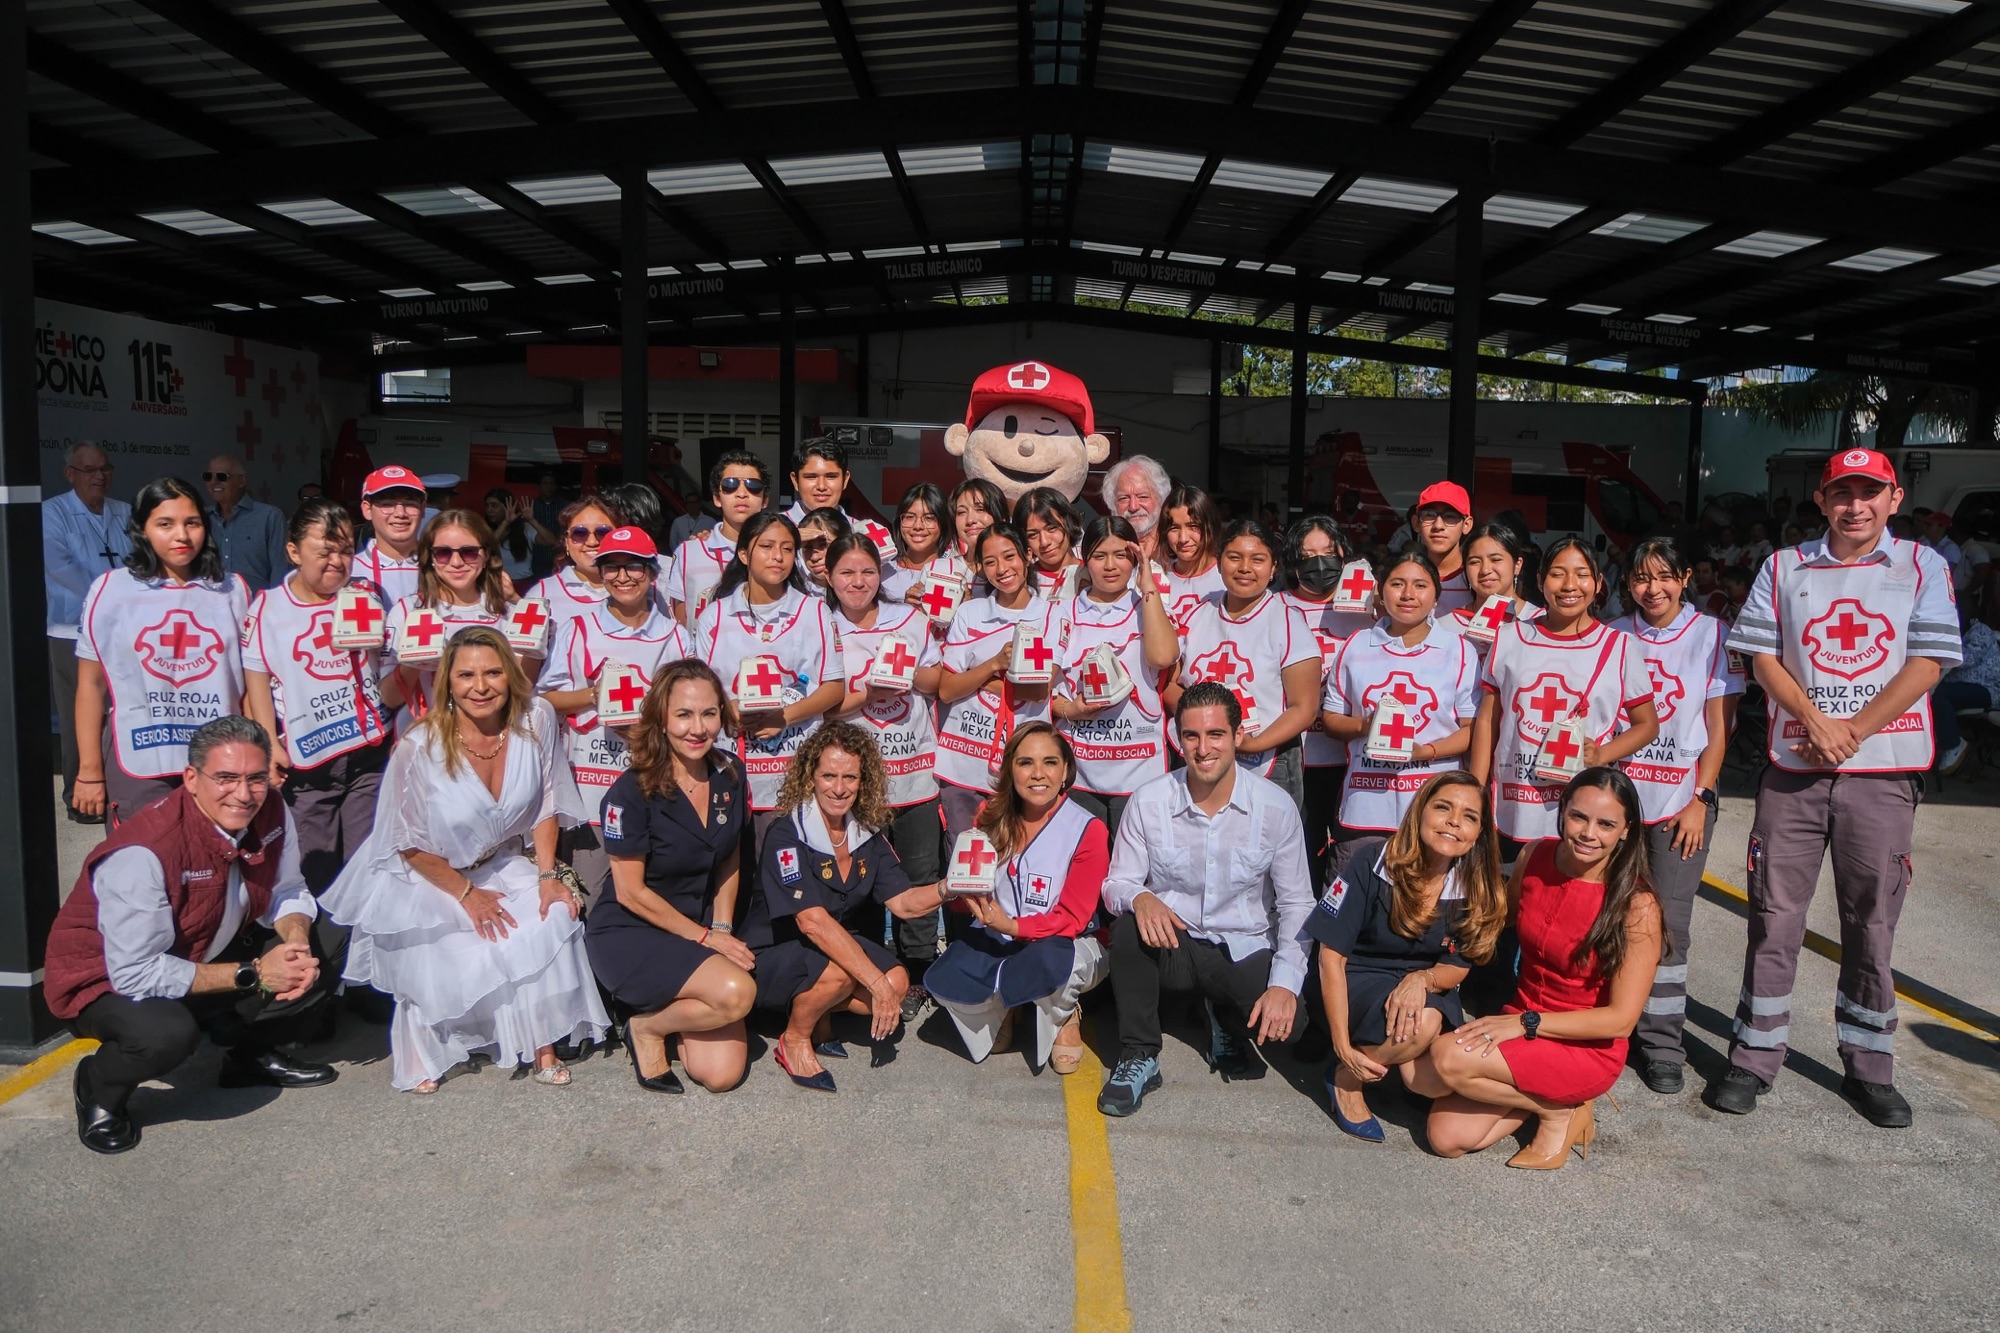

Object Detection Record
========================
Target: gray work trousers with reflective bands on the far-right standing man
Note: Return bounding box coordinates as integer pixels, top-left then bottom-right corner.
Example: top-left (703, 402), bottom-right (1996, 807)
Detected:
top-left (1730, 765), bottom-right (1922, 1083)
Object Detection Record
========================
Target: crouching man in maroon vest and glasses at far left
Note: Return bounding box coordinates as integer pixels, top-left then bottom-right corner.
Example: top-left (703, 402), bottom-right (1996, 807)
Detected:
top-left (42, 717), bottom-right (344, 1153)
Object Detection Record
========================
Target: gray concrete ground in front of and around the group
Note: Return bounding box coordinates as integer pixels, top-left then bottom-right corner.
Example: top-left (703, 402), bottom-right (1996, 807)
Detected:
top-left (0, 756), bottom-right (2000, 1333)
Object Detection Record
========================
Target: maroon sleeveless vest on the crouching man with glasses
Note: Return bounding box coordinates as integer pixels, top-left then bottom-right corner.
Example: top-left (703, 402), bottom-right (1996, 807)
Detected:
top-left (42, 787), bottom-right (284, 1019)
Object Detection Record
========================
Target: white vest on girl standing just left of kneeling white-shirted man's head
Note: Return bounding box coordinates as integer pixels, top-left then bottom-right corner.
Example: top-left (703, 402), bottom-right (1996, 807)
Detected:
top-left (1058, 592), bottom-right (1166, 797)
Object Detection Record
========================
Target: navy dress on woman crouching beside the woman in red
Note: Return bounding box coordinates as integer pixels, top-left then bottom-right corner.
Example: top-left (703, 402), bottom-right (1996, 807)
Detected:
top-left (1306, 839), bottom-right (1470, 1047)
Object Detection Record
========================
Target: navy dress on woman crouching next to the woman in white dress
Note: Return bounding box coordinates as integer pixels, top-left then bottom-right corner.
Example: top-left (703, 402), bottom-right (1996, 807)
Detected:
top-left (584, 751), bottom-right (750, 1013)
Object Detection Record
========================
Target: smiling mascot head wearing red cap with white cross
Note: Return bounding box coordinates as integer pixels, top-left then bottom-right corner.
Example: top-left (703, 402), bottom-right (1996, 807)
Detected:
top-left (944, 360), bottom-right (1112, 508)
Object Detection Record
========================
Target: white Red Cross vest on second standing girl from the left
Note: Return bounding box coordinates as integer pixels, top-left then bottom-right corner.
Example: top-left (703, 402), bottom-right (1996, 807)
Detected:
top-left (242, 578), bottom-right (388, 769)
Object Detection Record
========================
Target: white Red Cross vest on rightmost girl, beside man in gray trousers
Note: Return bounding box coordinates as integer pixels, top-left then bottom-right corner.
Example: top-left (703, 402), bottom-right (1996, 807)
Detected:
top-left (1612, 606), bottom-right (1744, 825)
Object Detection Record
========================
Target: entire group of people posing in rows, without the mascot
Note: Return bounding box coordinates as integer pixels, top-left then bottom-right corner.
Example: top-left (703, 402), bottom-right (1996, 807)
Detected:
top-left (46, 440), bottom-right (1958, 1169)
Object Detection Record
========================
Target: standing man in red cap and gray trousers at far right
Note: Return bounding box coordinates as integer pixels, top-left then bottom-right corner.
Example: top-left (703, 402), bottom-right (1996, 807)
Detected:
top-left (1710, 448), bottom-right (1960, 1129)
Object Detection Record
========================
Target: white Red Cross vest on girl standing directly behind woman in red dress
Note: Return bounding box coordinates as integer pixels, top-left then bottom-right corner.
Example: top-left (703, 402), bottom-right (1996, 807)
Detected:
top-left (1480, 620), bottom-right (1652, 843)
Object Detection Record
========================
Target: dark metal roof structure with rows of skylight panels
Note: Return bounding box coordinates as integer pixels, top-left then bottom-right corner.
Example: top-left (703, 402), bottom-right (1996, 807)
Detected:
top-left (26, 0), bottom-right (2000, 384)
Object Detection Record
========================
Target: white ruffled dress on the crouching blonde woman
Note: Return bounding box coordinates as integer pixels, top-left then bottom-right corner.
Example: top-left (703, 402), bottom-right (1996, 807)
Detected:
top-left (320, 699), bottom-right (610, 1091)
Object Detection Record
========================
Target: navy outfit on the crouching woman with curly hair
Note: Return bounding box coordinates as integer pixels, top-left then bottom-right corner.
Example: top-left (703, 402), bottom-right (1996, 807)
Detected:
top-left (744, 811), bottom-right (910, 1009)
